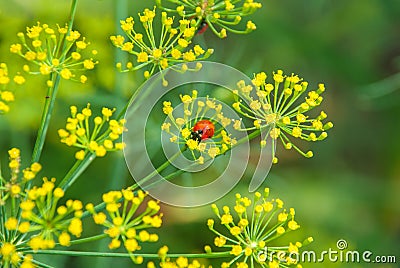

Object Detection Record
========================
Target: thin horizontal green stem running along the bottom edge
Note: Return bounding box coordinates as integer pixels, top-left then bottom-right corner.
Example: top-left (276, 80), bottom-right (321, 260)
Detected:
top-left (24, 249), bottom-right (231, 259)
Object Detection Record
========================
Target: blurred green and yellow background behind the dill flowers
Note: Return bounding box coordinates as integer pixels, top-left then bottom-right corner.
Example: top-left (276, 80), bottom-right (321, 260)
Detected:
top-left (0, 0), bottom-right (400, 267)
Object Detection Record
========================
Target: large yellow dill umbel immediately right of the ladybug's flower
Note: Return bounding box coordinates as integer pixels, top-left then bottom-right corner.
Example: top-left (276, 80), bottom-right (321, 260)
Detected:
top-left (233, 70), bottom-right (333, 163)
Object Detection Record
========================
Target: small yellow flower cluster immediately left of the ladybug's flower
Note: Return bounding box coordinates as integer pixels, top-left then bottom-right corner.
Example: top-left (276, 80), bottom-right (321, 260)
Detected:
top-left (58, 104), bottom-right (125, 160)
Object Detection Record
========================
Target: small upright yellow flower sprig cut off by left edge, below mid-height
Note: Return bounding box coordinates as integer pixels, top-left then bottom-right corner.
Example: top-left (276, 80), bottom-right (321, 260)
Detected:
top-left (0, 148), bottom-right (42, 205)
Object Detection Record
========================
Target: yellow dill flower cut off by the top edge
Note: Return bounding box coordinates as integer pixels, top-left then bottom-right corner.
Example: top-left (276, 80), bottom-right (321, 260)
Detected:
top-left (156, 0), bottom-right (262, 38)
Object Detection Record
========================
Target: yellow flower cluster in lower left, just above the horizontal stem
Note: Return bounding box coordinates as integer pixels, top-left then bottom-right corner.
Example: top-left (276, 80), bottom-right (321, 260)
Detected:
top-left (13, 178), bottom-right (83, 250)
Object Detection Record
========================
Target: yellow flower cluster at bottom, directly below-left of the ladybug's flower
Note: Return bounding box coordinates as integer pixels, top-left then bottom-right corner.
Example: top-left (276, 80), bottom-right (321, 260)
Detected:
top-left (86, 189), bottom-right (162, 263)
